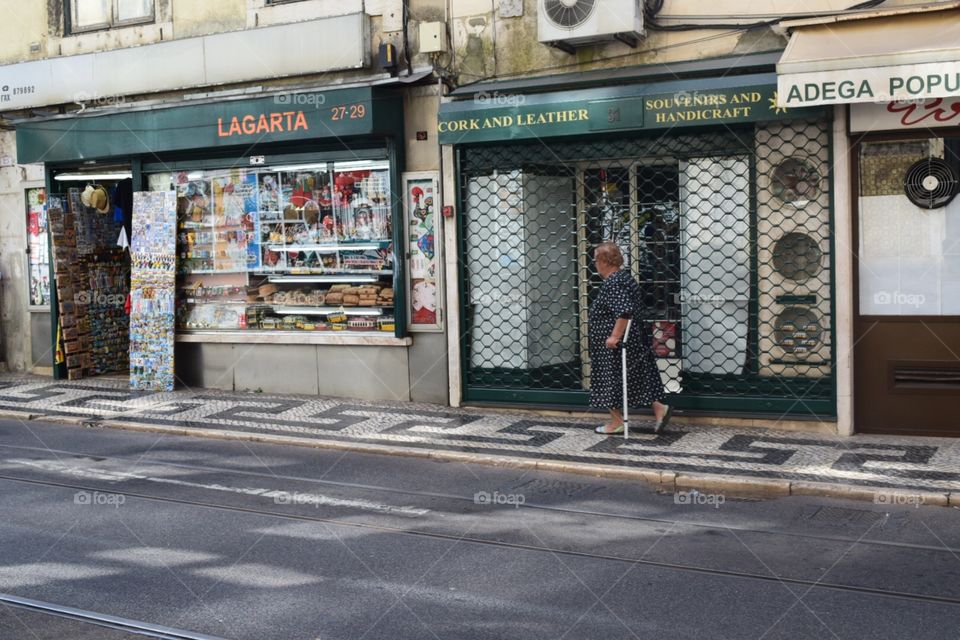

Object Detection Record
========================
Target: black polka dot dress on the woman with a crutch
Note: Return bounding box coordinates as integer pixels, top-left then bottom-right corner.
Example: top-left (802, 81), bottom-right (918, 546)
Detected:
top-left (589, 271), bottom-right (664, 409)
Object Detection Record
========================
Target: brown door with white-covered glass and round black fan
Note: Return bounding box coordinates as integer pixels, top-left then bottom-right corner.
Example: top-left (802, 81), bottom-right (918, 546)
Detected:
top-left (854, 138), bottom-right (960, 436)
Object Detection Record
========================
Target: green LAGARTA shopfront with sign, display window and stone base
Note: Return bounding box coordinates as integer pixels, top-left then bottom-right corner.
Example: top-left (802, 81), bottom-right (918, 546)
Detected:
top-left (16, 87), bottom-right (424, 399)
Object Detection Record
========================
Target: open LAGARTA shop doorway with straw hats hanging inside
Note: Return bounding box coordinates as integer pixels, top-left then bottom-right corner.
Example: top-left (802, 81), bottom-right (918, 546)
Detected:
top-left (47, 166), bottom-right (133, 380)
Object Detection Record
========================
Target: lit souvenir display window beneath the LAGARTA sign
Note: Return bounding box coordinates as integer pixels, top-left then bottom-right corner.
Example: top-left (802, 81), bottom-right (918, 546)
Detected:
top-left (149, 161), bottom-right (395, 333)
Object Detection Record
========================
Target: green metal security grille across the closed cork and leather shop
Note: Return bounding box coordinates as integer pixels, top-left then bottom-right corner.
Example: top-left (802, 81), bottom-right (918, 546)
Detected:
top-left (459, 121), bottom-right (834, 415)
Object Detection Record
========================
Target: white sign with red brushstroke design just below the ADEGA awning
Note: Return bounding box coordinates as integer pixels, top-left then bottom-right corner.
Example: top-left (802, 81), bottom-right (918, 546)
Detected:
top-left (850, 98), bottom-right (960, 133)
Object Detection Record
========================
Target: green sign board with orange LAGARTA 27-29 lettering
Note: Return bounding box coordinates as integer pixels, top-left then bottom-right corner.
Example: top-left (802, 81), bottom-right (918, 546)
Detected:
top-left (17, 87), bottom-right (402, 162)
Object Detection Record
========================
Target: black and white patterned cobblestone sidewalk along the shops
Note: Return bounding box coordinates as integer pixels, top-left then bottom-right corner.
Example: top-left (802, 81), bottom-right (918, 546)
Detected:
top-left (0, 374), bottom-right (960, 504)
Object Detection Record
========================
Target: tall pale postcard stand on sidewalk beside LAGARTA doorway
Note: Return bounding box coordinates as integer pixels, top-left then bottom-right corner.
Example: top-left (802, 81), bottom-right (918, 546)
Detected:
top-left (130, 191), bottom-right (177, 391)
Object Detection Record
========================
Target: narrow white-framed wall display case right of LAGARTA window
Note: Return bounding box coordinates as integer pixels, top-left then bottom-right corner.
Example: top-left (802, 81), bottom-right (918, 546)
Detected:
top-left (404, 172), bottom-right (441, 331)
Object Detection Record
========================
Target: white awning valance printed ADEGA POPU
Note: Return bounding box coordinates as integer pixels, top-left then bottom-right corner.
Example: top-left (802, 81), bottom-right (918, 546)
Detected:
top-left (777, 62), bottom-right (960, 107)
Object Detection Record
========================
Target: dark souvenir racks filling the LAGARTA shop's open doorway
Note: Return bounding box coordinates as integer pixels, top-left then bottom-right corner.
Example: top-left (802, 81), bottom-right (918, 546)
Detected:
top-left (47, 189), bottom-right (129, 380)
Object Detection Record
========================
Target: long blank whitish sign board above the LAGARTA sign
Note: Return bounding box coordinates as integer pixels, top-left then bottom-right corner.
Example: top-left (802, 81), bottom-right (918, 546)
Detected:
top-left (0, 13), bottom-right (370, 111)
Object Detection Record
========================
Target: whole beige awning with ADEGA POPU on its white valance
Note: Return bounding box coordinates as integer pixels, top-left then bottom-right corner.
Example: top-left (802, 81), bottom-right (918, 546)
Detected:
top-left (777, 1), bottom-right (960, 107)
